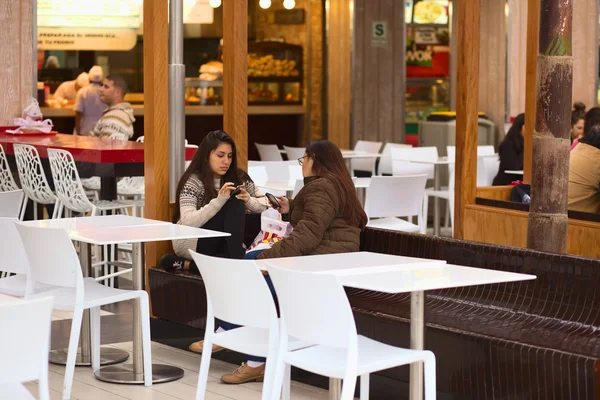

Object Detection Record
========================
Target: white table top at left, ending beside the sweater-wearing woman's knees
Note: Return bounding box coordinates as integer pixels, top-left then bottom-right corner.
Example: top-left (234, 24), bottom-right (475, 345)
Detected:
top-left (69, 224), bottom-right (231, 245)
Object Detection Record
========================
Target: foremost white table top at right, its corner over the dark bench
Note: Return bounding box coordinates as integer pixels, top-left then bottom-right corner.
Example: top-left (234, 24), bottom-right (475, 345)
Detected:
top-left (339, 264), bottom-right (536, 293)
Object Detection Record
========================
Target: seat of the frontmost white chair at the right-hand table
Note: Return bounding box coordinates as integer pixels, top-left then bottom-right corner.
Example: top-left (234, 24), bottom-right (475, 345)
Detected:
top-left (284, 335), bottom-right (432, 379)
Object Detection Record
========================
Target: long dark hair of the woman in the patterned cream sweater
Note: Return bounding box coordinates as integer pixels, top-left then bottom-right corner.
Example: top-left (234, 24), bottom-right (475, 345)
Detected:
top-left (173, 130), bottom-right (243, 223)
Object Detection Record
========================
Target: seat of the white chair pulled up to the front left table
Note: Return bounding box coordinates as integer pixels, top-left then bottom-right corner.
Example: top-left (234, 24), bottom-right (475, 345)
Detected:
top-left (30, 278), bottom-right (145, 311)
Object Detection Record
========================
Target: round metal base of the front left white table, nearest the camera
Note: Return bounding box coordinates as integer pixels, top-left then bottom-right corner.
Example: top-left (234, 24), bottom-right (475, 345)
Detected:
top-left (95, 364), bottom-right (183, 385)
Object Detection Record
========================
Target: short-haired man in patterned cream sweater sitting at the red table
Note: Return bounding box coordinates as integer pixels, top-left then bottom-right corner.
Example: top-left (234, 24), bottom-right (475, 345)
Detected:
top-left (91, 75), bottom-right (135, 140)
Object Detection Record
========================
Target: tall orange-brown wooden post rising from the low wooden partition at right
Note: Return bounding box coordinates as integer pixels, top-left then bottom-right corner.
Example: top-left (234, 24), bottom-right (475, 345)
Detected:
top-left (454, 0), bottom-right (480, 239)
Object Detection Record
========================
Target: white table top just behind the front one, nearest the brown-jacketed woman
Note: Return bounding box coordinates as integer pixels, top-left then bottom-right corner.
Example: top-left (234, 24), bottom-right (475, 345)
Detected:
top-left (257, 251), bottom-right (446, 276)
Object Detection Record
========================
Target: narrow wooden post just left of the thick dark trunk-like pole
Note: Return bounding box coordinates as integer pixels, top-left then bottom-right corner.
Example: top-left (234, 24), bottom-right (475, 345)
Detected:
top-left (523, 0), bottom-right (540, 183)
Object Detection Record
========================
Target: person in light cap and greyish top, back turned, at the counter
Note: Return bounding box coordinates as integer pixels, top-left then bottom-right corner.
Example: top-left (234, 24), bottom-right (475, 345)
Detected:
top-left (74, 65), bottom-right (107, 136)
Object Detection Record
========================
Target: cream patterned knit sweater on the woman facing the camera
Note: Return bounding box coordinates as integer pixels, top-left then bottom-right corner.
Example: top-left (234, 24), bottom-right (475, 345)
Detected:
top-left (173, 174), bottom-right (268, 260)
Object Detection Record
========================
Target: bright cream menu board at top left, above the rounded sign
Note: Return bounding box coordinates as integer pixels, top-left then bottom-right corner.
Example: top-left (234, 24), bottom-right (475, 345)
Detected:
top-left (37, 0), bottom-right (140, 29)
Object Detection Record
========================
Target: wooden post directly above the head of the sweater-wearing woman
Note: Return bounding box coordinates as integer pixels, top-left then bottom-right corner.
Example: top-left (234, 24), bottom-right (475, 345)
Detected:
top-left (223, 0), bottom-right (248, 169)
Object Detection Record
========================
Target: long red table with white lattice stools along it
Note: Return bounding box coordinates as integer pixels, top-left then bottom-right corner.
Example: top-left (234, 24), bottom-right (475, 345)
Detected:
top-left (0, 133), bottom-right (197, 200)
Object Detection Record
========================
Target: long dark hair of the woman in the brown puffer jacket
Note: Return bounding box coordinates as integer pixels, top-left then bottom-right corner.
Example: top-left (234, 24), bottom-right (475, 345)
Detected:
top-left (306, 140), bottom-right (367, 229)
